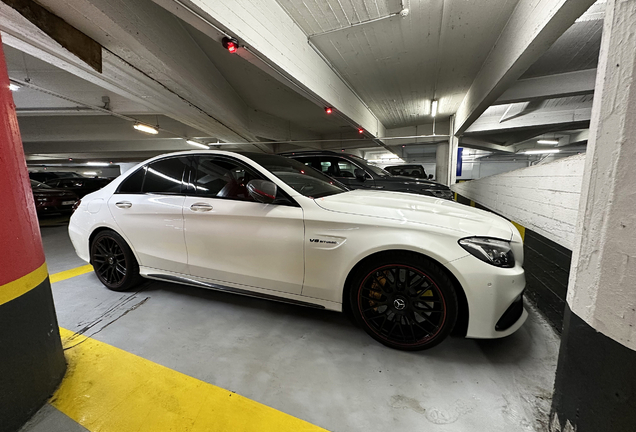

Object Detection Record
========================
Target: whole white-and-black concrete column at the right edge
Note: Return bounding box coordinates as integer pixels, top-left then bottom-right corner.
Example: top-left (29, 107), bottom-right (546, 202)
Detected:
top-left (550, 0), bottom-right (636, 432)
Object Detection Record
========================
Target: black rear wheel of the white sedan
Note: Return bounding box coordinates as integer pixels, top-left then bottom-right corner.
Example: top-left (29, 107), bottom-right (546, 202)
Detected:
top-left (91, 230), bottom-right (141, 291)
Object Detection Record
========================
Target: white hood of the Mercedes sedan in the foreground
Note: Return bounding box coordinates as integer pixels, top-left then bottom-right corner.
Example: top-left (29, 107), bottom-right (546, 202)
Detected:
top-left (315, 189), bottom-right (513, 240)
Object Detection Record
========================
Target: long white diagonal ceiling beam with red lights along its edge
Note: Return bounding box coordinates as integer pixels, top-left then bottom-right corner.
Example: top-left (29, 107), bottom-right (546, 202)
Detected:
top-left (153, 0), bottom-right (384, 137)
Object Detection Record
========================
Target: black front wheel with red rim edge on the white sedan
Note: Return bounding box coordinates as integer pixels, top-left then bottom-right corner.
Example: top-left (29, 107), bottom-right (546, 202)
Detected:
top-left (349, 252), bottom-right (458, 351)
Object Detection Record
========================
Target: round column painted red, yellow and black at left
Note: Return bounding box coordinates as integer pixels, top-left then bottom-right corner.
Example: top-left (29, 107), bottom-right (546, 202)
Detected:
top-left (0, 40), bottom-right (66, 432)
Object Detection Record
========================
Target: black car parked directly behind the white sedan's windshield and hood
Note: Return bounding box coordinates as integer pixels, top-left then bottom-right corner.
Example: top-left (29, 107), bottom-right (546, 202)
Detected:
top-left (281, 150), bottom-right (453, 199)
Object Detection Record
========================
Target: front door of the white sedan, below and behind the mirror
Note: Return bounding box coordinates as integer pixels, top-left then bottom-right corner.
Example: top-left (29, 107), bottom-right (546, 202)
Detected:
top-left (184, 155), bottom-right (304, 294)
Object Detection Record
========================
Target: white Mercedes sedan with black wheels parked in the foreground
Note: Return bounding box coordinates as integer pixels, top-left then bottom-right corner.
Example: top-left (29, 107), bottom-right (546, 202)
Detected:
top-left (69, 150), bottom-right (527, 350)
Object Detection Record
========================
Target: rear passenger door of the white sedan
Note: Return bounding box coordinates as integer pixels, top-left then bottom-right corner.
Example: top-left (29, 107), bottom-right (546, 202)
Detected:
top-left (108, 157), bottom-right (189, 274)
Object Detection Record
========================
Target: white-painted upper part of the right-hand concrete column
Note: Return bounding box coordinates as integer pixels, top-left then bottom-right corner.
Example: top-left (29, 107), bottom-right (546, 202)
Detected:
top-left (568, 0), bottom-right (636, 352)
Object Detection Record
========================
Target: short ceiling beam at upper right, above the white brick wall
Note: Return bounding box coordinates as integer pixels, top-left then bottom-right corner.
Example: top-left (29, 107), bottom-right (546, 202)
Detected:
top-left (493, 69), bottom-right (596, 105)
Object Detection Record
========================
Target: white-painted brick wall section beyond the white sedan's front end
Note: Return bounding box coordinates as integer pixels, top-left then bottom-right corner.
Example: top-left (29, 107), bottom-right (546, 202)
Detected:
top-left (451, 155), bottom-right (585, 250)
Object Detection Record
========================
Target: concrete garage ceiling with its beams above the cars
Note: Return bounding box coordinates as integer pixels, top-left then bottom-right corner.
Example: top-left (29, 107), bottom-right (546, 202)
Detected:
top-left (0, 0), bottom-right (604, 165)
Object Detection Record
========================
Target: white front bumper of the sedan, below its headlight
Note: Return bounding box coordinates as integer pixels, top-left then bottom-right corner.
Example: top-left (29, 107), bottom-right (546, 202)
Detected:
top-left (446, 255), bottom-right (528, 339)
